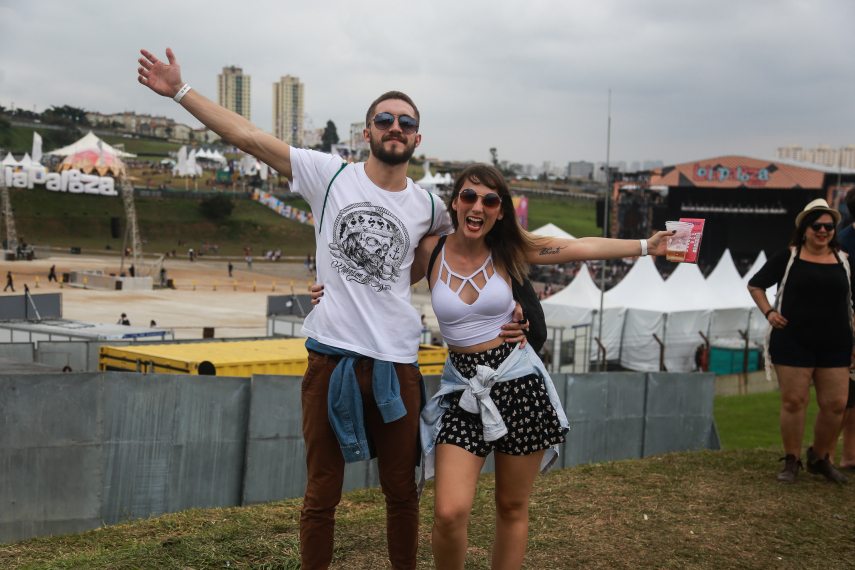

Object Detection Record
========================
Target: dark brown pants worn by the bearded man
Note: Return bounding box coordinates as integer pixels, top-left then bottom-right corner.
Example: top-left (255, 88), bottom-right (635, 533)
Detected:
top-left (300, 351), bottom-right (421, 570)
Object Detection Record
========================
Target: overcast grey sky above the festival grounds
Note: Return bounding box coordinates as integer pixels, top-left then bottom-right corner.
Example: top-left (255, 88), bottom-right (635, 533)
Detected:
top-left (0, 0), bottom-right (855, 165)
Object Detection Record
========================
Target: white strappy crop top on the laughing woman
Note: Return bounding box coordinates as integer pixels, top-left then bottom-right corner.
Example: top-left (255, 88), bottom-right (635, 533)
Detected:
top-left (430, 246), bottom-right (516, 347)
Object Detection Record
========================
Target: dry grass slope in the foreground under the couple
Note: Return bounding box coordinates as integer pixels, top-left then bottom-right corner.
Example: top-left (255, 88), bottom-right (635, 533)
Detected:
top-left (0, 449), bottom-right (855, 570)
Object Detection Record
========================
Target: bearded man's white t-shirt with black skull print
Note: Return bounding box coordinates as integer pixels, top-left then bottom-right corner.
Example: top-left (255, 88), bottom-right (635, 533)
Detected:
top-left (291, 148), bottom-right (454, 363)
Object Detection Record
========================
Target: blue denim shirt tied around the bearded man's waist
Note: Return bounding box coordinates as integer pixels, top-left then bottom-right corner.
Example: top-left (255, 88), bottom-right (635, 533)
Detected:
top-left (306, 338), bottom-right (424, 463)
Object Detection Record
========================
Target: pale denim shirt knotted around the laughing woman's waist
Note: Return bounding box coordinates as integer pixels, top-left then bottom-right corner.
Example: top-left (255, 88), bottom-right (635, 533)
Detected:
top-left (419, 345), bottom-right (570, 493)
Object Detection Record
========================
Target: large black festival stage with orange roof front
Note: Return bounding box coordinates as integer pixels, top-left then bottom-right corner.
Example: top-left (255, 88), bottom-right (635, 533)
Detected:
top-left (611, 156), bottom-right (855, 268)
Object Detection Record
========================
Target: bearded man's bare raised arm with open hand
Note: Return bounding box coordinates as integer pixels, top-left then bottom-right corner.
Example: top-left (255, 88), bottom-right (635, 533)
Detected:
top-left (137, 48), bottom-right (291, 179)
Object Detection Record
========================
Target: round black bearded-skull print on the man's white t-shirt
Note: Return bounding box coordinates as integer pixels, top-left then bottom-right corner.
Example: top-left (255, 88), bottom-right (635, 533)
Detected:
top-left (330, 202), bottom-right (410, 292)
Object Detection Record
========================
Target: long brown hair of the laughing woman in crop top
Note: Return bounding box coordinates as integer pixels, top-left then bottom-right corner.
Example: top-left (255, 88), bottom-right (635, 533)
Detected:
top-left (447, 164), bottom-right (547, 283)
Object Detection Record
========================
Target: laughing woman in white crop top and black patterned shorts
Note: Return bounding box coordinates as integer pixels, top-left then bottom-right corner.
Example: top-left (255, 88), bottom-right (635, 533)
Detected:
top-left (411, 164), bottom-right (669, 569)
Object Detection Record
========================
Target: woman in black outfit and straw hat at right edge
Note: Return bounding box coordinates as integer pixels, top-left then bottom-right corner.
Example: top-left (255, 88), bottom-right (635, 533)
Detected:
top-left (748, 198), bottom-right (855, 483)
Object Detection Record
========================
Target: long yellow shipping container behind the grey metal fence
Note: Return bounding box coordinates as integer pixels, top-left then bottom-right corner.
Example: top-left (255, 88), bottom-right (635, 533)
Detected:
top-left (98, 338), bottom-right (448, 376)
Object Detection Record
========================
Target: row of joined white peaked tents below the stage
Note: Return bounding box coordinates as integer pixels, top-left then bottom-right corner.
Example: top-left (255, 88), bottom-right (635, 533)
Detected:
top-left (542, 251), bottom-right (771, 372)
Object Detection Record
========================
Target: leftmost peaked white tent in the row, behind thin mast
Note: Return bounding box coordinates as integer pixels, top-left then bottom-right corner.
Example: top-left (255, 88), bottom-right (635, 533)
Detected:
top-left (540, 264), bottom-right (626, 360)
